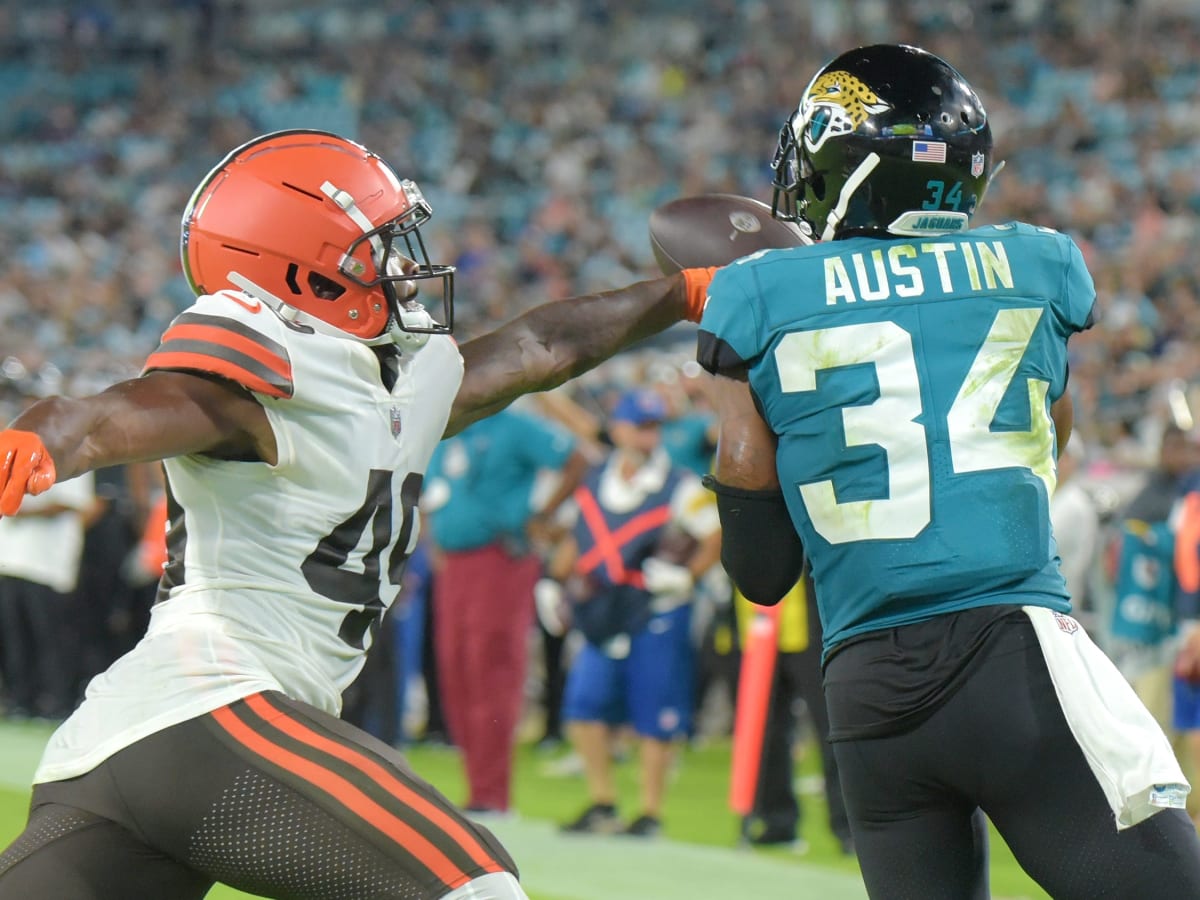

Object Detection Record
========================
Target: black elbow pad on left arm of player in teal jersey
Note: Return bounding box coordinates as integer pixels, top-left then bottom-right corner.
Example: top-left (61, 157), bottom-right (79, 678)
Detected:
top-left (703, 475), bottom-right (804, 606)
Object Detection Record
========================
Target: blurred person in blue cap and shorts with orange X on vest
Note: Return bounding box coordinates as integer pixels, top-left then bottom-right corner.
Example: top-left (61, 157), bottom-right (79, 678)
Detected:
top-left (550, 389), bottom-right (721, 838)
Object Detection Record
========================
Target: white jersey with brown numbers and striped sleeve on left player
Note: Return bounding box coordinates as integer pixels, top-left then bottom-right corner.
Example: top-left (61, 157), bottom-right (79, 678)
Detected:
top-left (35, 292), bottom-right (463, 781)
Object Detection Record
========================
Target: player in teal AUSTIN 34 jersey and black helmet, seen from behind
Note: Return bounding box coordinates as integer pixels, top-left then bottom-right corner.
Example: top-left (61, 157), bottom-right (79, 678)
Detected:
top-left (698, 44), bottom-right (1200, 900)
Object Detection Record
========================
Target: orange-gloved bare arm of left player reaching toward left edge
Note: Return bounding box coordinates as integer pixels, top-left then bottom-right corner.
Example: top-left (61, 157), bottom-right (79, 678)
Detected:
top-left (0, 371), bottom-right (276, 514)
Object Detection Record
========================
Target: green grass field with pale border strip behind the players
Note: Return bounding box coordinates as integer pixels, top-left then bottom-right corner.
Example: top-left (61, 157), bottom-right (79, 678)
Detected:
top-left (0, 721), bottom-right (1048, 900)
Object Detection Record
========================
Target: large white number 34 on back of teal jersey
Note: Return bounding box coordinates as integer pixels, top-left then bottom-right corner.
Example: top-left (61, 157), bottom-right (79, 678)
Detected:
top-left (775, 307), bottom-right (1055, 544)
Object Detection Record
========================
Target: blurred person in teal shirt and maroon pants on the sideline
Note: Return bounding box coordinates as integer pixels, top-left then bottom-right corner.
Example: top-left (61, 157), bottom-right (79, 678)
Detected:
top-left (426, 409), bottom-right (587, 814)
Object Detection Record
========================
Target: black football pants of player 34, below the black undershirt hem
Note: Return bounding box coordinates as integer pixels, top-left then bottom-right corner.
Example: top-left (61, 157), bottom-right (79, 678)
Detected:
top-left (834, 622), bottom-right (1200, 900)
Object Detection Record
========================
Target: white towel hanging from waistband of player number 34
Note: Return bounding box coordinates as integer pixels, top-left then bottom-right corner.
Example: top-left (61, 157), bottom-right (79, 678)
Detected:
top-left (1024, 606), bottom-right (1192, 829)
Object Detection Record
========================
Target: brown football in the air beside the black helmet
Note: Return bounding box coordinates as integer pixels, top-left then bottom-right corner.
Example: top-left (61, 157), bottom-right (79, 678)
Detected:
top-left (650, 193), bottom-right (812, 275)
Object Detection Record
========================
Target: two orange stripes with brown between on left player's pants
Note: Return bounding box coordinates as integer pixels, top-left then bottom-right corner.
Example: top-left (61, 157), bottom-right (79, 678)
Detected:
top-left (212, 695), bottom-right (504, 887)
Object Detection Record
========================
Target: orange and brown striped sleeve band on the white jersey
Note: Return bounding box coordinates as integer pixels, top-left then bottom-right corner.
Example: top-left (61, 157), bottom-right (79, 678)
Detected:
top-left (142, 312), bottom-right (295, 397)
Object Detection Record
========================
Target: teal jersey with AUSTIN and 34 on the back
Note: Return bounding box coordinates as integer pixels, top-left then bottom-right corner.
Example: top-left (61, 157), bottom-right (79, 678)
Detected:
top-left (698, 223), bottom-right (1096, 654)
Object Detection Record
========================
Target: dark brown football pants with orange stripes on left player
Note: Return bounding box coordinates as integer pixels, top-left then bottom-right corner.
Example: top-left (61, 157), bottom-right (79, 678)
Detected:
top-left (0, 694), bottom-right (516, 900)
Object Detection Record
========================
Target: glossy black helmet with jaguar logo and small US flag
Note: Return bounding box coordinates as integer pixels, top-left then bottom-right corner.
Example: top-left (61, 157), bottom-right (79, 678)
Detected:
top-left (772, 44), bottom-right (994, 240)
